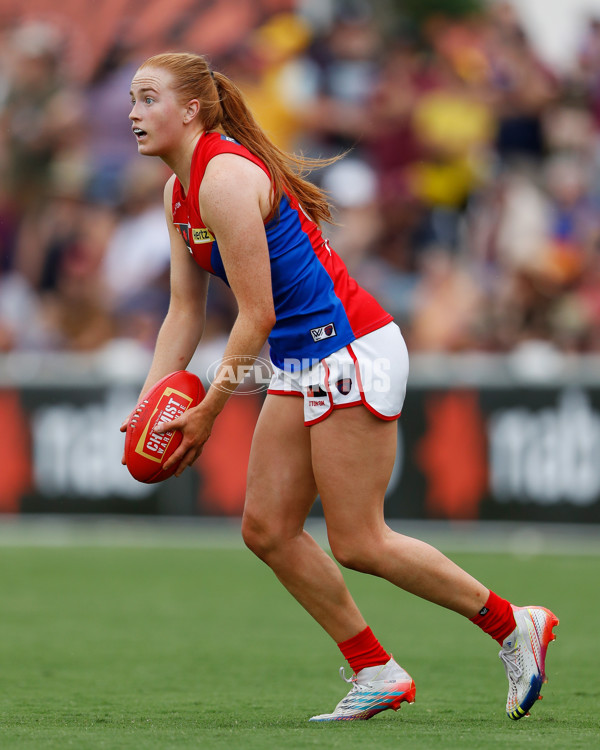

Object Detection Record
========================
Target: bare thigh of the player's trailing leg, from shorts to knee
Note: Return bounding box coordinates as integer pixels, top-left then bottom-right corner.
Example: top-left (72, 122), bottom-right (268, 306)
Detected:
top-left (311, 406), bottom-right (398, 537)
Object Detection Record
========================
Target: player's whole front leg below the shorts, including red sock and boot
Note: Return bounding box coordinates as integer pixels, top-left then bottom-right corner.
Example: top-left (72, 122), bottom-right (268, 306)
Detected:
top-left (242, 395), bottom-right (415, 721)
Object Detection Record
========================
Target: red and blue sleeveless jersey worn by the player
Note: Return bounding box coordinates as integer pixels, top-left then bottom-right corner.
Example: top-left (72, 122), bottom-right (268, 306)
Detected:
top-left (172, 132), bottom-right (393, 371)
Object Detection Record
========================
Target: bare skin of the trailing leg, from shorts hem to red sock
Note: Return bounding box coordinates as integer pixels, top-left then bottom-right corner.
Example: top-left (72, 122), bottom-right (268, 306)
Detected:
top-left (311, 406), bottom-right (489, 617)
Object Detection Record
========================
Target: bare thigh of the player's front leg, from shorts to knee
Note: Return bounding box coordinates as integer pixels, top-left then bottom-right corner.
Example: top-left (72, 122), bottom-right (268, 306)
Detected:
top-left (244, 394), bottom-right (317, 533)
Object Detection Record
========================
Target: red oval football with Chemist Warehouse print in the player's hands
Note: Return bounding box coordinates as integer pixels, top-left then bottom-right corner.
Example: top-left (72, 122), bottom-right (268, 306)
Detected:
top-left (125, 370), bottom-right (205, 484)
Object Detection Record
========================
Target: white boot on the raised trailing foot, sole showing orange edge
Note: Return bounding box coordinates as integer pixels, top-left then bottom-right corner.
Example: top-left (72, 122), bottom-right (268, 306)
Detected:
top-left (498, 607), bottom-right (558, 721)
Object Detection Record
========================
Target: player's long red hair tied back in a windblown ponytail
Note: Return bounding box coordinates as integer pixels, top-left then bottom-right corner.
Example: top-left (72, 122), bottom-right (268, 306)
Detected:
top-left (141, 53), bottom-right (341, 223)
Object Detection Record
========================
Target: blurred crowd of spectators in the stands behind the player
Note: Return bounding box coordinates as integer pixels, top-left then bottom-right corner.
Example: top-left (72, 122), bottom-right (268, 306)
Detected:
top-left (0, 1), bottom-right (600, 360)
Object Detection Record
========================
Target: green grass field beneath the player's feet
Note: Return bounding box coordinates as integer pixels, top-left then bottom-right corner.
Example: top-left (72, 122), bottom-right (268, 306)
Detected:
top-left (0, 524), bottom-right (600, 750)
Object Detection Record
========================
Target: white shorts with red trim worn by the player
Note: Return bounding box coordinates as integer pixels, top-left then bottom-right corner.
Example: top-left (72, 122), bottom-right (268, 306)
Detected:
top-left (267, 323), bottom-right (408, 425)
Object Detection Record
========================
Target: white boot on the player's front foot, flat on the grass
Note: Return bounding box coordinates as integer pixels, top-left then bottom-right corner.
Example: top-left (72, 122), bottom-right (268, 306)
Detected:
top-left (310, 659), bottom-right (416, 721)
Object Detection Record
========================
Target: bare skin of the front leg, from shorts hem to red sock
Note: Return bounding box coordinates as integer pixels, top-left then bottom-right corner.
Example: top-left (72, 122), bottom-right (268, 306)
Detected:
top-left (242, 394), bottom-right (366, 642)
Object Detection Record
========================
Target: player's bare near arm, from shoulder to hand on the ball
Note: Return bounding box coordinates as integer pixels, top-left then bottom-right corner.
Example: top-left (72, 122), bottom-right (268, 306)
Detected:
top-left (160, 154), bottom-right (275, 476)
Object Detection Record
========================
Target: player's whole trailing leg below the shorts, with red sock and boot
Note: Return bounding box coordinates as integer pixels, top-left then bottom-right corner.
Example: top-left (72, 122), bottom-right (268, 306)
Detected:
top-left (311, 407), bottom-right (558, 719)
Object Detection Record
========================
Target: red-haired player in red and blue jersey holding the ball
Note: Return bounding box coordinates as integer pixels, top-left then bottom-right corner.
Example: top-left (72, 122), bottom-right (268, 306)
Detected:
top-left (122, 53), bottom-right (558, 721)
